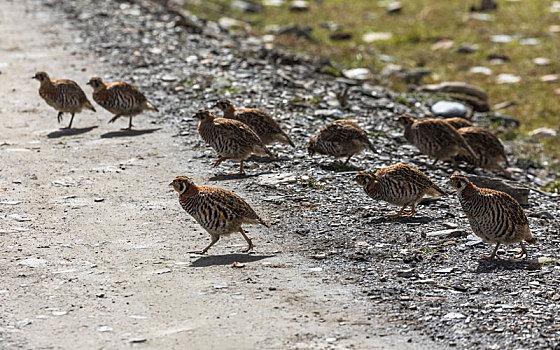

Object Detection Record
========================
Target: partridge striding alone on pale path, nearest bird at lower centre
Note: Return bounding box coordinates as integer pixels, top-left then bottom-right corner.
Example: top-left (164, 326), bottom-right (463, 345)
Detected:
top-left (169, 176), bottom-right (268, 254)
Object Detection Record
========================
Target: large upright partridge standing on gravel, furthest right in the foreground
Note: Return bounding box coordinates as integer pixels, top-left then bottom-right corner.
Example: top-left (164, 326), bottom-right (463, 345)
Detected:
top-left (450, 174), bottom-right (536, 260)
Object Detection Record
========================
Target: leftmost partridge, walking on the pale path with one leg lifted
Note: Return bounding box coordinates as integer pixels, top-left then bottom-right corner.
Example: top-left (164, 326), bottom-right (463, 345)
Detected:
top-left (32, 72), bottom-right (95, 129)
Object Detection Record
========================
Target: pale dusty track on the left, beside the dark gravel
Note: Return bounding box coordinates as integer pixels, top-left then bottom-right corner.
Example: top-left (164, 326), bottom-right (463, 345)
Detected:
top-left (0, 1), bottom-right (442, 349)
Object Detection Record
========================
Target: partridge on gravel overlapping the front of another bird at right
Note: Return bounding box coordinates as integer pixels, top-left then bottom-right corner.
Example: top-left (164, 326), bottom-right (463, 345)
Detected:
top-left (399, 115), bottom-right (477, 168)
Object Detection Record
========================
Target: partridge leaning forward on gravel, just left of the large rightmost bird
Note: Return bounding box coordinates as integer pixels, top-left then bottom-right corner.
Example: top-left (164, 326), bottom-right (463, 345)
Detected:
top-left (356, 163), bottom-right (446, 217)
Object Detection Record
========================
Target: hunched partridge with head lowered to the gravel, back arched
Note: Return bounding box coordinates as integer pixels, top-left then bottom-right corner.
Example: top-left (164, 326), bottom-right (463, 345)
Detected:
top-left (307, 119), bottom-right (375, 165)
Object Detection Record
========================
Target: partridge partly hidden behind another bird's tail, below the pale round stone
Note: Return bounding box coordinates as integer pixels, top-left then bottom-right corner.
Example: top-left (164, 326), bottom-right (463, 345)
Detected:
top-left (457, 126), bottom-right (511, 178)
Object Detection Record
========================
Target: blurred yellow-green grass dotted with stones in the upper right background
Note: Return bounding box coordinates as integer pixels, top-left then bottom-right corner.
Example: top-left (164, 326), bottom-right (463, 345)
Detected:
top-left (185, 0), bottom-right (560, 165)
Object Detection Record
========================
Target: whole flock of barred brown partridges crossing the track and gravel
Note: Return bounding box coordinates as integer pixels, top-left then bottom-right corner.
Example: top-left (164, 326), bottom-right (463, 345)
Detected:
top-left (33, 72), bottom-right (536, 260)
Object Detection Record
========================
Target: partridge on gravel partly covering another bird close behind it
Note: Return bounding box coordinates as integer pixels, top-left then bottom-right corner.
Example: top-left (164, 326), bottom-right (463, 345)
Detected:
top-left (194, 109), bottom-right (272, 175)
